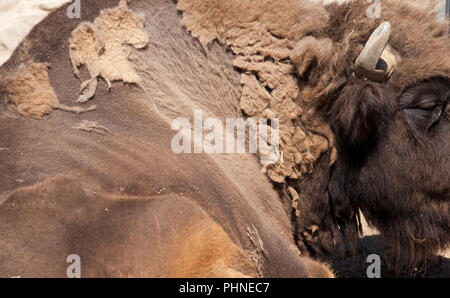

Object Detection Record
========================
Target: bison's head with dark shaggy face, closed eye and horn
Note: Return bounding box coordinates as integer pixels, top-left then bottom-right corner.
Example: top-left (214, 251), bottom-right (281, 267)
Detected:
top-left (291, 1), bottom-right (450, 263)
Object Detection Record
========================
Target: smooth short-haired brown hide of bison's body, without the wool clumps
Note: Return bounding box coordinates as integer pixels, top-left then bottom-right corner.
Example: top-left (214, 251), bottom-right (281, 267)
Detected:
top-left (0, 0), bottom-right (332, 277)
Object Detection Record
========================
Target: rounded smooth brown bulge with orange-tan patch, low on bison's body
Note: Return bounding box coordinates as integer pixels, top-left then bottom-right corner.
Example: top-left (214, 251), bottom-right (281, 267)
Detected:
top-left (0, 175), bottom-right (257, 277)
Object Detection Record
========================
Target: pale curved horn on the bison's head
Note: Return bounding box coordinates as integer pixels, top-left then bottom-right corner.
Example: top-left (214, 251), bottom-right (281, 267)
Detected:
top-left (355, 22), bottom-right (397, 82)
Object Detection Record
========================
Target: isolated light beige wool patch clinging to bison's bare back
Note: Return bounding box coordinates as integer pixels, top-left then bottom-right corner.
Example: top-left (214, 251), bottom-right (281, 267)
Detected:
top-left (69, 0), bottom-right (149, 102)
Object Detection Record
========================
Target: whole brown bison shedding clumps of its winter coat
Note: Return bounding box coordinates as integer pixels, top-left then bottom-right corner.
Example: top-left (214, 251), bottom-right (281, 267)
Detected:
top-left (0, 0), bottom-right (450, 277)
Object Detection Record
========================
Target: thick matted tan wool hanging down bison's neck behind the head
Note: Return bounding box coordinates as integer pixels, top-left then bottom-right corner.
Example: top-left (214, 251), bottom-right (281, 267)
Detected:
top-left (177, 0), bottom-right (333, 183)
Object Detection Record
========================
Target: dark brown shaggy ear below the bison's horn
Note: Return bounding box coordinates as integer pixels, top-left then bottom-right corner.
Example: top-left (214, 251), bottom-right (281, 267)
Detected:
top-left (329, 83), bottom-right (388, 152)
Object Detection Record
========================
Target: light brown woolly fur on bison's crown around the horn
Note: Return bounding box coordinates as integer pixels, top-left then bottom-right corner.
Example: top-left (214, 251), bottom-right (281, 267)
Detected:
top-left (291, 1), bottom-right (450, 101)
